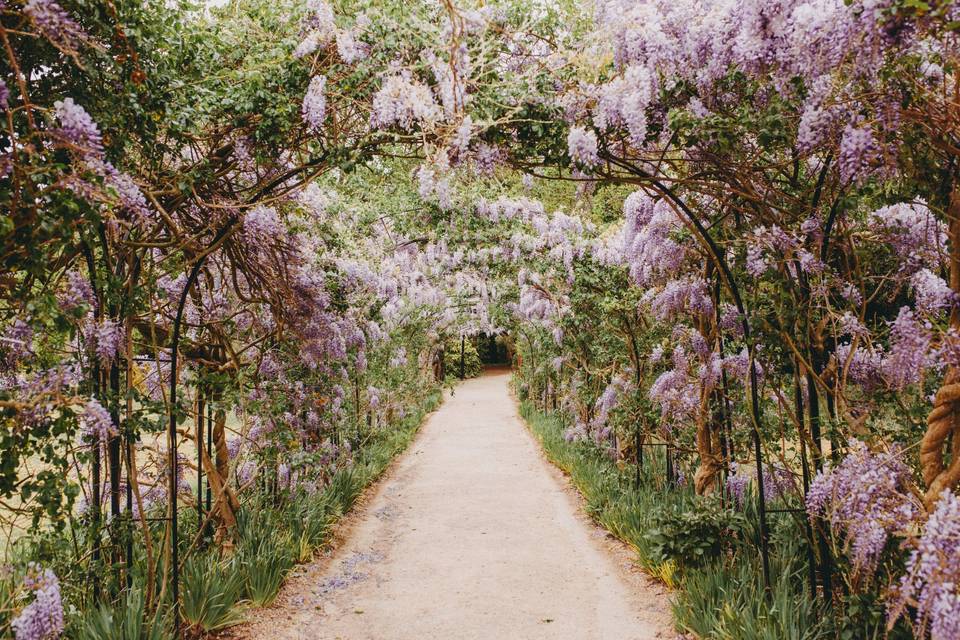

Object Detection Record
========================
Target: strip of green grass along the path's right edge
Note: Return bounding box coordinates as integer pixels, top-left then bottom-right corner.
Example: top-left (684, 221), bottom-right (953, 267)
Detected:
top-left (521, 402), bottom-right (836, 640)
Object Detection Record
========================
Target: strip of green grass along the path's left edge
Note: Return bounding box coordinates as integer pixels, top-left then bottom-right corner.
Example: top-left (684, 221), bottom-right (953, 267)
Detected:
top-left (62, 391), bottom-right (441, 640)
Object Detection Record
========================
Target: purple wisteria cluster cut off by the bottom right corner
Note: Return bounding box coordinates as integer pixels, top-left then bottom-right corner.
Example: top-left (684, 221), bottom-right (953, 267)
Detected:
top-left (887, 491), bottom-right (960, 640)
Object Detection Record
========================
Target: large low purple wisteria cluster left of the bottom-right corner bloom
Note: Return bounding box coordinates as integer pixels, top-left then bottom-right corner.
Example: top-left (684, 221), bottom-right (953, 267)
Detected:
top-left (807, 440), bottom-right (922, 581)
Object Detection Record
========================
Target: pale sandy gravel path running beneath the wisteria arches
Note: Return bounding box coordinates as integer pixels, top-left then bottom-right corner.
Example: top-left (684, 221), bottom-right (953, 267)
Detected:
top-left (230, 371), bottom-right (676, 640)
